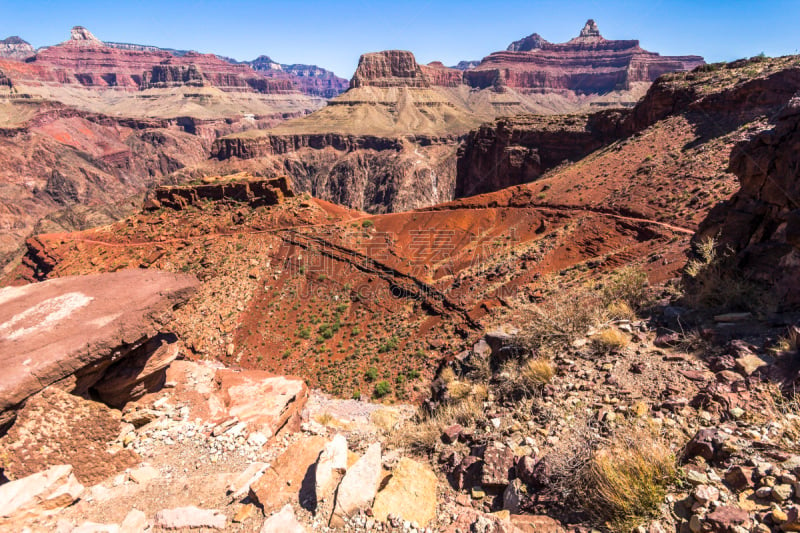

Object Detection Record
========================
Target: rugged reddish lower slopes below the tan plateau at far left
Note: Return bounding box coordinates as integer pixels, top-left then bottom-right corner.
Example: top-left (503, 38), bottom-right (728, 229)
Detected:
top-left (0, 101), bottom-right (217, 264)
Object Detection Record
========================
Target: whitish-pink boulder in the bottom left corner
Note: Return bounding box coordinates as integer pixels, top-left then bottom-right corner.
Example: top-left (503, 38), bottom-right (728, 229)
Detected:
top-left (0, 465), bottom-right (84, 525)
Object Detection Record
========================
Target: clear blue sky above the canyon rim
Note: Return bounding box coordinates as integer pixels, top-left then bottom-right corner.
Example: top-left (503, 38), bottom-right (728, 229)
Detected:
top-left (0, 0), bottom-right (800, 78)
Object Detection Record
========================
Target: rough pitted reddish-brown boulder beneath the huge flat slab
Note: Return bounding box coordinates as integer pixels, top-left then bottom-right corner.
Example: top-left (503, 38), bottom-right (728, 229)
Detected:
top-left (0, 386), bottom-right (139, 486)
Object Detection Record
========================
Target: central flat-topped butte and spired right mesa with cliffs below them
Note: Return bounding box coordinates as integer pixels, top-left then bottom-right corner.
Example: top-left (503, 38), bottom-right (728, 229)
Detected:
top-left (213, 21), bottom-right (702, 216)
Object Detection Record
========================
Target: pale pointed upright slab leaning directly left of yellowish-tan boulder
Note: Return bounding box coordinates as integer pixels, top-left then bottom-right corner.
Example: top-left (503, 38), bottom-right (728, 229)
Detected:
top-left (330, 442), bottom-right (381, 527)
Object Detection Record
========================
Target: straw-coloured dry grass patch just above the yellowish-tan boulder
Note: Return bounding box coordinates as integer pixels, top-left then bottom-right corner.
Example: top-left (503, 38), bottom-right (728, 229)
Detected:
top-left (394, 399), bottom-right (485, 455)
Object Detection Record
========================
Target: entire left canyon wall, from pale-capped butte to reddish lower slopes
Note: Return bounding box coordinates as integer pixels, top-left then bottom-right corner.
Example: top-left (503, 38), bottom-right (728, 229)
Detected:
top-left (0, 26), bottom-right (332, 265)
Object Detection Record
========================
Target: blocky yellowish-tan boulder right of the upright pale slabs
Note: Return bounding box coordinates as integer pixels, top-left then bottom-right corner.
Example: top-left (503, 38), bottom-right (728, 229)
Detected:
top-left (372, 457), bottom-right (437, 527)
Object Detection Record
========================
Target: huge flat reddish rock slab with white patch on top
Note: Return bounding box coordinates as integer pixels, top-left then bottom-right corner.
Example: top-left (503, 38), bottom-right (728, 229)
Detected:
top-left (0, 270), bottom-right (199, 426)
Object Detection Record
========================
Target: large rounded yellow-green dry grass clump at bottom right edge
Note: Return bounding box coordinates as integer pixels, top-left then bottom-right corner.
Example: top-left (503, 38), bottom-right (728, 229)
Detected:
top-left (581, 428), bottom-right (678, 531)
